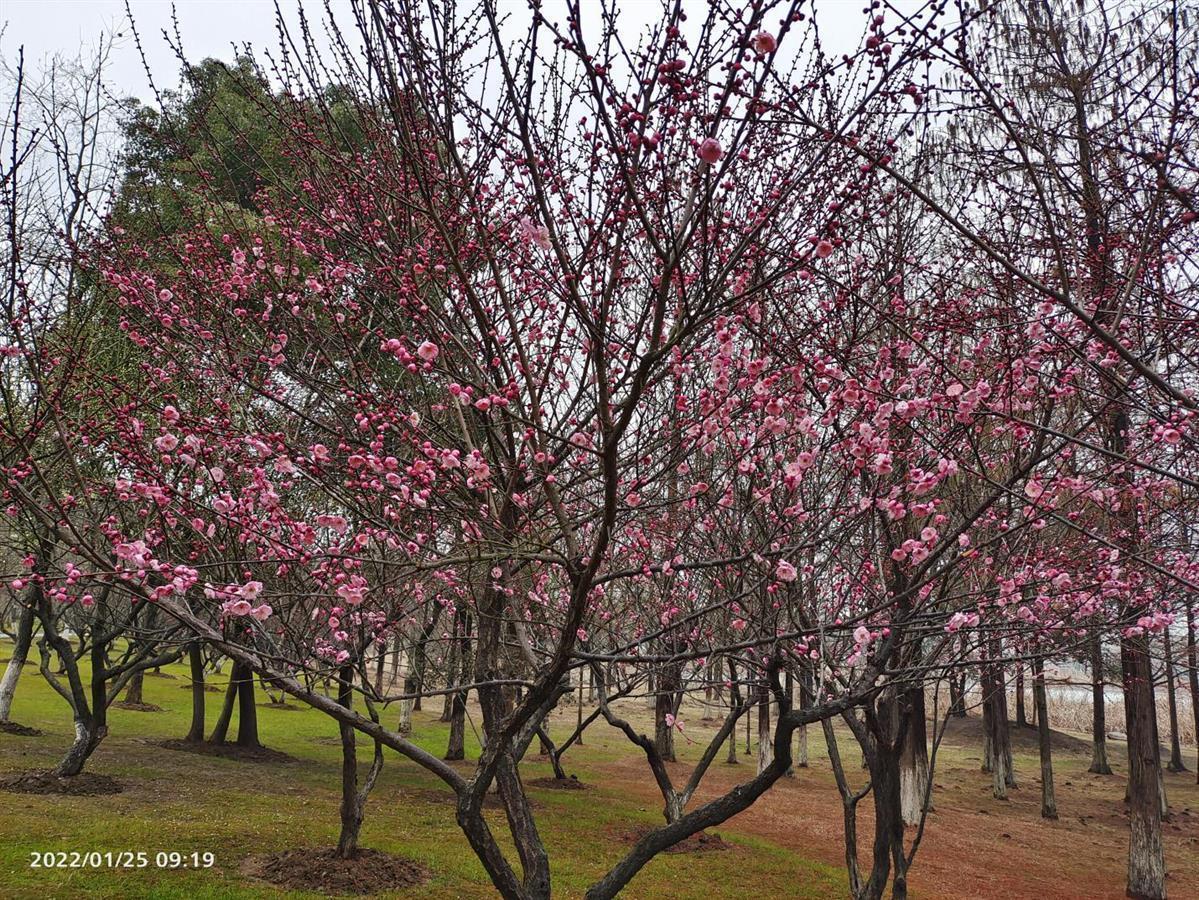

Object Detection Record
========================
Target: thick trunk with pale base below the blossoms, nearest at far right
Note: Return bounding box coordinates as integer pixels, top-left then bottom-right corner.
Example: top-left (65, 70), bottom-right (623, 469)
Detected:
top-left (1120, 635), bottom-right (1165, 900)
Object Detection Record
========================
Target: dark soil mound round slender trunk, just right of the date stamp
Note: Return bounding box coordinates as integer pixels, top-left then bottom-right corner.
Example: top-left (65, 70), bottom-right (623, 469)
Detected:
top-left (241, 848), bottom-right (429, 896)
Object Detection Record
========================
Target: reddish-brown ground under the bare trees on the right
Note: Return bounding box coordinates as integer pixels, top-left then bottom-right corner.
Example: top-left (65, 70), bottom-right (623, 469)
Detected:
top-left (580, 714), bottom-right (1199, 900)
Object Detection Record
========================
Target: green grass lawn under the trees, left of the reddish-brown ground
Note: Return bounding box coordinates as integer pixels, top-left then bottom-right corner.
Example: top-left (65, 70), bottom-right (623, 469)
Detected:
top-left (0, 645), bottom-right (845, 900)
